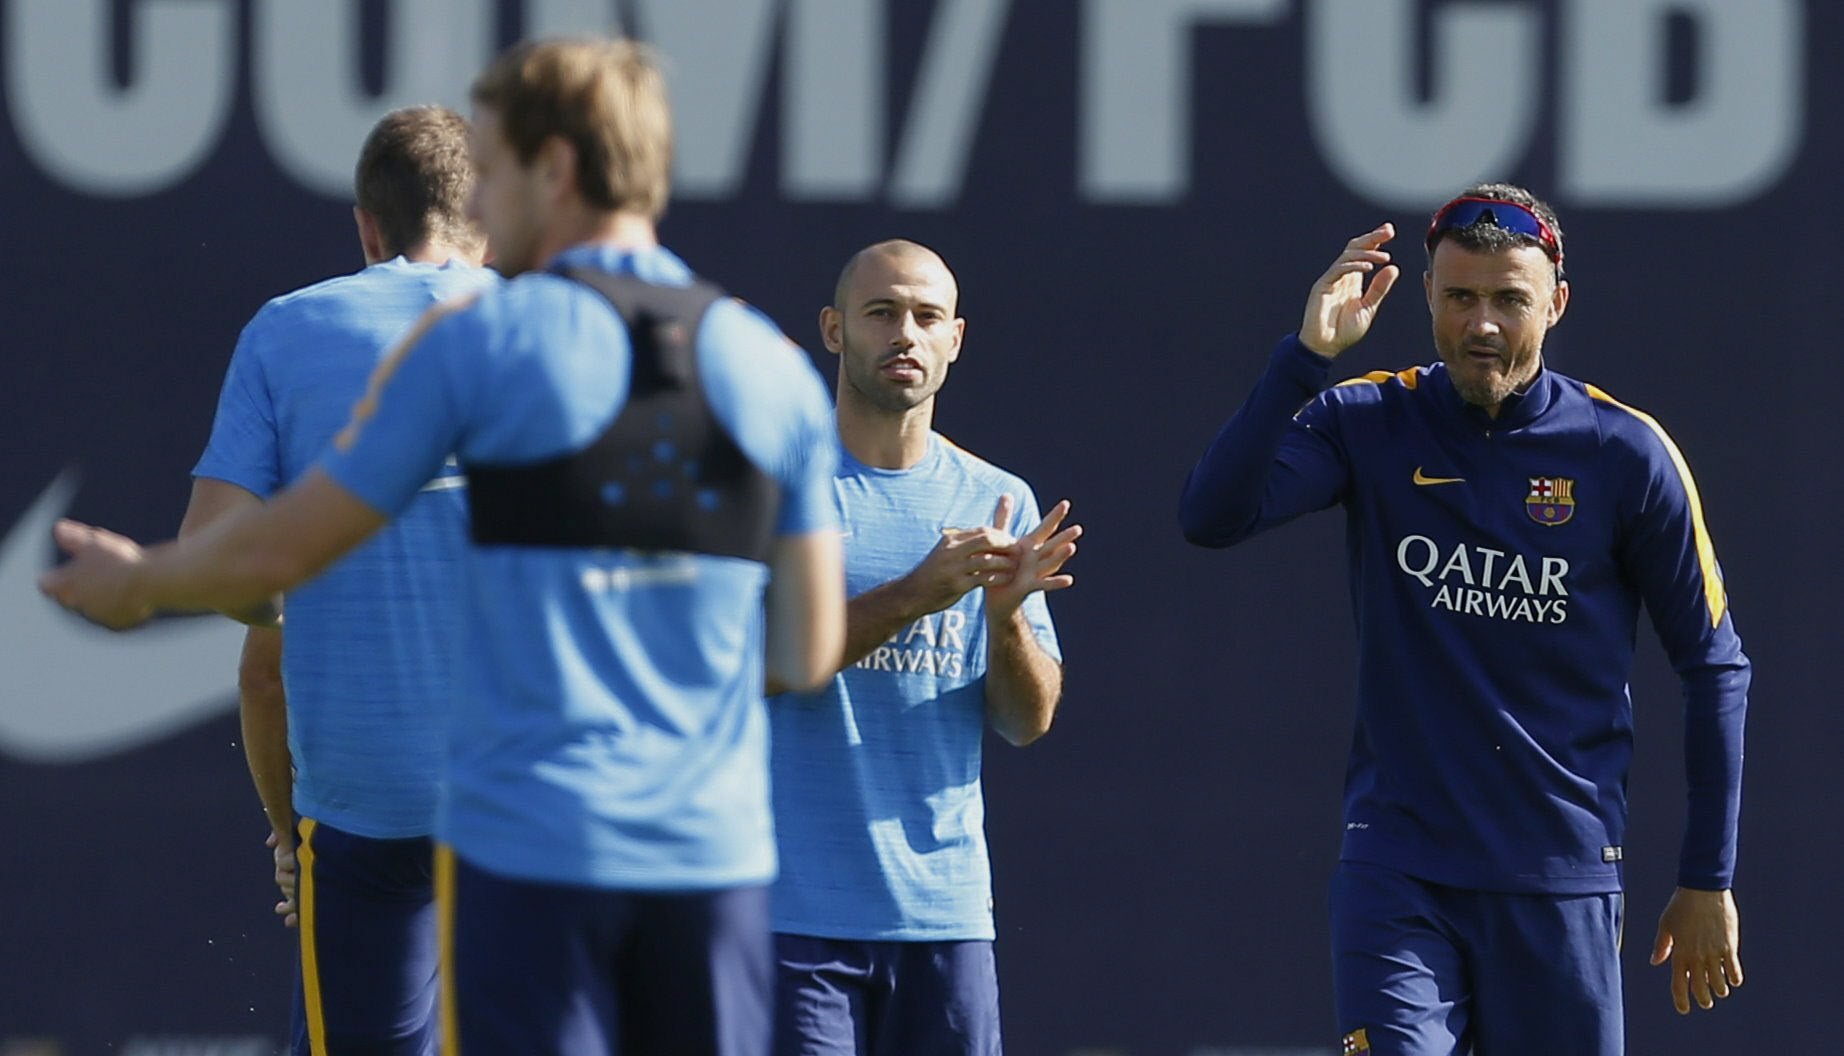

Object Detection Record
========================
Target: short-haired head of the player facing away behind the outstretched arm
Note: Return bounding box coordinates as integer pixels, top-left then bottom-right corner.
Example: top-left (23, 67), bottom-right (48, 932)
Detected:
top-left (352, 107), bottom-right (479, 254)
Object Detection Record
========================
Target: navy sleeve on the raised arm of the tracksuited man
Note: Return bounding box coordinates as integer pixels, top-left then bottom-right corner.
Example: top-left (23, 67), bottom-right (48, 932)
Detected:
top-left (1178, 335), bottom-right (1350, 547)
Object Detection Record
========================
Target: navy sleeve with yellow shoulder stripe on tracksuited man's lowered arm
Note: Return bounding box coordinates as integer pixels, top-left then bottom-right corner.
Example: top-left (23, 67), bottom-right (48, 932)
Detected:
top-left (1621, 420), bottom-right (1750, 890)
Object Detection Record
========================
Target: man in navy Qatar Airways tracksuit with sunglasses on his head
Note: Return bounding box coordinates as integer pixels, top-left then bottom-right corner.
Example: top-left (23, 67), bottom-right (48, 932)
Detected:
top-left (1180, 184), bottom-right (1748, 1056)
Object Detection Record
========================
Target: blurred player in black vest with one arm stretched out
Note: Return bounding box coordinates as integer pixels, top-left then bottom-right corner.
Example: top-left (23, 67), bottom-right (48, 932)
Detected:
top-left (44, 41), bottom-right (845, 1056)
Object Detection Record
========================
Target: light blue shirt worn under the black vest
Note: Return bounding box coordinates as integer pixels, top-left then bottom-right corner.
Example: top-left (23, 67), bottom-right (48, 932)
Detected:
top-left (323, 245), bottom-right (839, 890)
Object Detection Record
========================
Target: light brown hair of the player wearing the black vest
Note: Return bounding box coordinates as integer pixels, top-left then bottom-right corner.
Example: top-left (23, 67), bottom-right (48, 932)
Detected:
top-left (472, 39), bottom-right (673, 219)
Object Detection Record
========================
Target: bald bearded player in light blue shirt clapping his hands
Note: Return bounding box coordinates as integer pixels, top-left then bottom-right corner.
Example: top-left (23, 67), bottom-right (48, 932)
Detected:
top-left (769, 241), bottom-right (1081, 1056)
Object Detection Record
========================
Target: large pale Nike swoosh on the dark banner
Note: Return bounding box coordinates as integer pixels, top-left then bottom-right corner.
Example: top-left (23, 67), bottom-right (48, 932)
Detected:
top-left (0, 470), bottom-right (243, 763)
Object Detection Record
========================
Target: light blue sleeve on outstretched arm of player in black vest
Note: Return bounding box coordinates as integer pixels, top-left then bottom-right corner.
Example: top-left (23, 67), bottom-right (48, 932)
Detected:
top-left (321, 308), bottom-right (481, 518)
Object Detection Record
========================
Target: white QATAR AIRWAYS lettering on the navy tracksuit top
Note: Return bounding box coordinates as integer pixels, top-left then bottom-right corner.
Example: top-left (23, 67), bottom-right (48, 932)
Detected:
top-left (1396, 534), bottom-right (1569, 623)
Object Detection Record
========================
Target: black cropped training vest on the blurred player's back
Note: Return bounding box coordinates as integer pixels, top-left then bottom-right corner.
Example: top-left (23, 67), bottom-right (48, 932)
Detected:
top-left (463, 269), bottom-right (780, 562)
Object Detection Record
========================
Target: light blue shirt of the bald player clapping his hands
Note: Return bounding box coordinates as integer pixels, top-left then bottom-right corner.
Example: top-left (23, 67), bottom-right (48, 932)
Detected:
top-left (769, 433), bottom-right (1062, 942)
